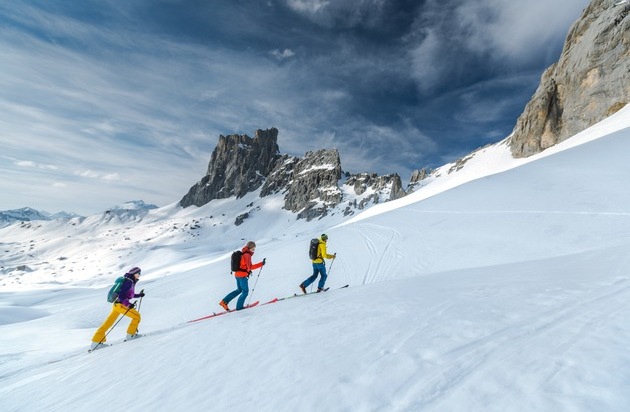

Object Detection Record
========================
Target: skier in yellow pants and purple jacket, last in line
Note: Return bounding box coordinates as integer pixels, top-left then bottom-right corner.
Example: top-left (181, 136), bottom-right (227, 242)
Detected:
top-left (92, 267), bottom-right (144, 349)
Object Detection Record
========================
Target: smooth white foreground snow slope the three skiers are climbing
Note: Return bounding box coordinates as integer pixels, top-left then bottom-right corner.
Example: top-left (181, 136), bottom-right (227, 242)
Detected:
top-left (0, 108), bottom-right (630, 412)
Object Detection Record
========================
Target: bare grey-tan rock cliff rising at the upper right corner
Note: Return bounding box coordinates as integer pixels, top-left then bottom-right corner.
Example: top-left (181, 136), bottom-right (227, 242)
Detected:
top-left (510, 0), bottom-right (630, 157)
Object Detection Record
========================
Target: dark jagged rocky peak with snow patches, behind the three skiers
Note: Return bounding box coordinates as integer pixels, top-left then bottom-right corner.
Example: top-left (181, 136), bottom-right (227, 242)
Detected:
top-left (180, 128), bottom-right (405, 220)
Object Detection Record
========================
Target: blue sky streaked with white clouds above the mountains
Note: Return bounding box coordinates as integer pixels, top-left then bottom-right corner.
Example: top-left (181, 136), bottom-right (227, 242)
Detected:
top-left (0, 0), bottom-right (588, 215)
